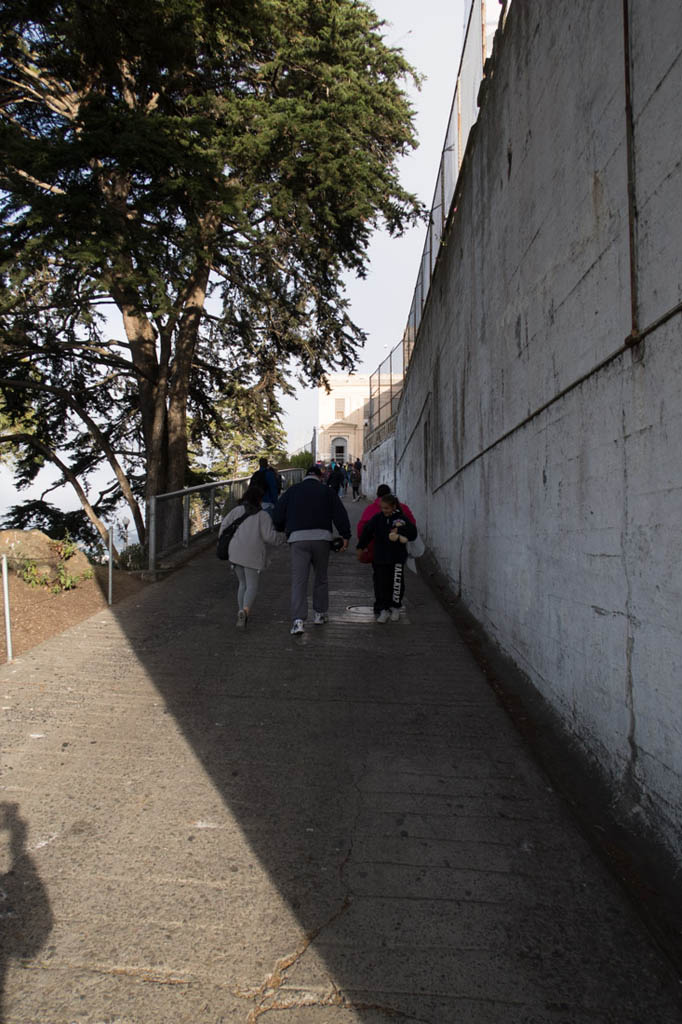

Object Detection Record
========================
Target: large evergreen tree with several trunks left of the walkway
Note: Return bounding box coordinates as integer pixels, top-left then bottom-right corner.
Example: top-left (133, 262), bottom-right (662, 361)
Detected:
top-left (0, 0), bottom-right (422, 538)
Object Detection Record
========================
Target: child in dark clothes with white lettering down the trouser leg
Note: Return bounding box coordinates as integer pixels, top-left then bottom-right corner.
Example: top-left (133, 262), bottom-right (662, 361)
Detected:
top-left (357, 495), bottom-right (417, 623)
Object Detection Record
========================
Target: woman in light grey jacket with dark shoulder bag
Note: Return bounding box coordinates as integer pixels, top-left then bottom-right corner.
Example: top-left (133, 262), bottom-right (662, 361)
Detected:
top-left (218, 487), bottom-right (286, 629)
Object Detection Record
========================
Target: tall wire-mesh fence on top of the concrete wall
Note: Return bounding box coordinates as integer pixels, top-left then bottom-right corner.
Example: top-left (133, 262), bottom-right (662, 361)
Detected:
top-left (370, 0), bottom-right (509, 431)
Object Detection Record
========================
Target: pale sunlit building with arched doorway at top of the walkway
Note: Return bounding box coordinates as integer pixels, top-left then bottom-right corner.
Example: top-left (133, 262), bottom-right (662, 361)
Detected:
top-left (317, 374), bottom-right (370, 463)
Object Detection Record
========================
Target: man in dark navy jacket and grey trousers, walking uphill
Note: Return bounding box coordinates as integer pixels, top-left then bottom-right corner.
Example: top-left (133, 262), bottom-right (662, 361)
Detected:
top-left (272, 466), bottom-right (350, 636)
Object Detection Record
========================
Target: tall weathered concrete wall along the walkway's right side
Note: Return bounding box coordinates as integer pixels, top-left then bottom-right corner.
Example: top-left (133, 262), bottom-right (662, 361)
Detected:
top-left (395, 0), bottom-right (682, 859)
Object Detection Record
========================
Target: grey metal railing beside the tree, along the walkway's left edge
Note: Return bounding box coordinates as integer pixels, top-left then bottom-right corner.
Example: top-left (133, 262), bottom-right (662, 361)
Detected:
top-left (147, 469), bottom-right (303, 572)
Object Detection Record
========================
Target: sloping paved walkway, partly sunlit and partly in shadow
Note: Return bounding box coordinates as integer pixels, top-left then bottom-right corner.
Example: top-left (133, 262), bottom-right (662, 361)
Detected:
top-left (4, 495), bottom-right (679, 1024)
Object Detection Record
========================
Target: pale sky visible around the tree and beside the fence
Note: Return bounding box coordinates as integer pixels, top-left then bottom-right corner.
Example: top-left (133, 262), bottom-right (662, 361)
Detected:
top-left (0, 0), bottom-right (470, 520)
